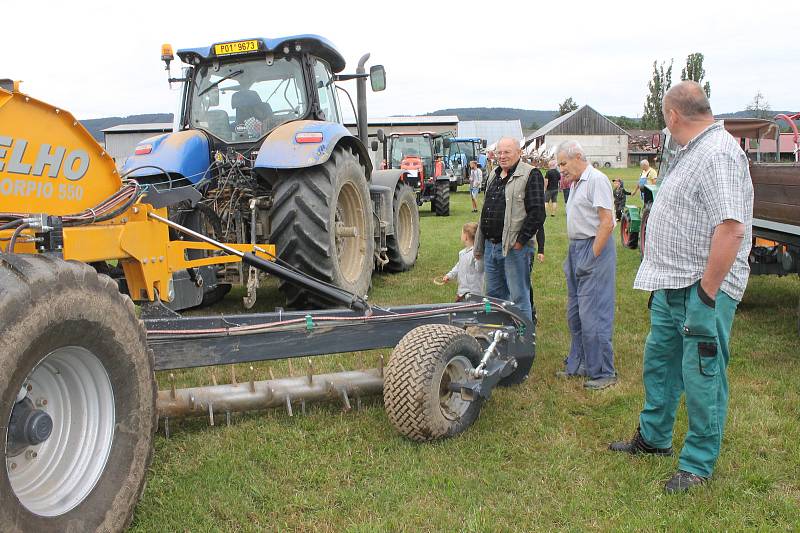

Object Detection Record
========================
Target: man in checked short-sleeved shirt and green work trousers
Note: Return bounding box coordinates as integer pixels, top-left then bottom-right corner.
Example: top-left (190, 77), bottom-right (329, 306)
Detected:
top-left (610, 81), bottom-right (753, 493)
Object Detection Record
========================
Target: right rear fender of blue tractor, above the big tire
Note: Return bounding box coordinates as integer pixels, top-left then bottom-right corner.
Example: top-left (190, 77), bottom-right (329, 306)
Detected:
top-left (255, 120), bottom-right (372, 174)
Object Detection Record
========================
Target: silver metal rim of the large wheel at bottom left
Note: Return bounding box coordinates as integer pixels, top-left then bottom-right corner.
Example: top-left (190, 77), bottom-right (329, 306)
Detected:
top-left (6, 346), bottom-right (115, 516)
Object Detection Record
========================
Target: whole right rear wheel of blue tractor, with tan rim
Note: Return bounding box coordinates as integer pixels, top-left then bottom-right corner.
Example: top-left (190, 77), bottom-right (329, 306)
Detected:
top-left (270, 146), bottom-right (375, 309)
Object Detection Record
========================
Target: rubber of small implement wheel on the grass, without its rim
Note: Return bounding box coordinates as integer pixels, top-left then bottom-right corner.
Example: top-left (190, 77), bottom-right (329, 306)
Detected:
top-left (383, 324), bottom-right (482, 442)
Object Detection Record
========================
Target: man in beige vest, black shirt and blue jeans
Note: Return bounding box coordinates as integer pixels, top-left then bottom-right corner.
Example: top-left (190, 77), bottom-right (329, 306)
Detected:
top-left (473, 137), bottom-right (545, 320)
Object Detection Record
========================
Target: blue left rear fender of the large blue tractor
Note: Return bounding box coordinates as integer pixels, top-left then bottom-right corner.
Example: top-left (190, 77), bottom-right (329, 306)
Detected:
top-left (122, 130), bottom-right (211, 184)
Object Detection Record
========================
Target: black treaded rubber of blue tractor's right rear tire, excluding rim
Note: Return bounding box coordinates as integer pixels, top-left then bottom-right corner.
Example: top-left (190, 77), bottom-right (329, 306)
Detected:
top-left (270, 147), bottom-right (374, 308)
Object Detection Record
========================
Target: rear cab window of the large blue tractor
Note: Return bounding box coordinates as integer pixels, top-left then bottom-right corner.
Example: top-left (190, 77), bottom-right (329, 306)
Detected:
top-left (190, 57), bottom-right (308, 142)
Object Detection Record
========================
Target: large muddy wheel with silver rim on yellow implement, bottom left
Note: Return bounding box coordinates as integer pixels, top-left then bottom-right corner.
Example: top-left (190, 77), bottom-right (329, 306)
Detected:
top-left (0, 254), bottom-right (156, 531)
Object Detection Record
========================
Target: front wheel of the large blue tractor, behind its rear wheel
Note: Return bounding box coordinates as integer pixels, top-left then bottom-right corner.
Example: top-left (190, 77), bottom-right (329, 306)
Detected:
top-left (385, 183), bottom-right (419, 272)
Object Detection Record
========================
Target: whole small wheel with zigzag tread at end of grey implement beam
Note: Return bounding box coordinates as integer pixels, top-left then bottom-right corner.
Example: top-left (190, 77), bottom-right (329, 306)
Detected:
top-left (383, 324), bottom-right (483, 442)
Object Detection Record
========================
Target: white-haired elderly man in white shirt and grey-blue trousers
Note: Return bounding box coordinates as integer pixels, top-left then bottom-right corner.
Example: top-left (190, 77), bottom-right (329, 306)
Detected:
top-left (557, 141), bottom-right (617, 390)
